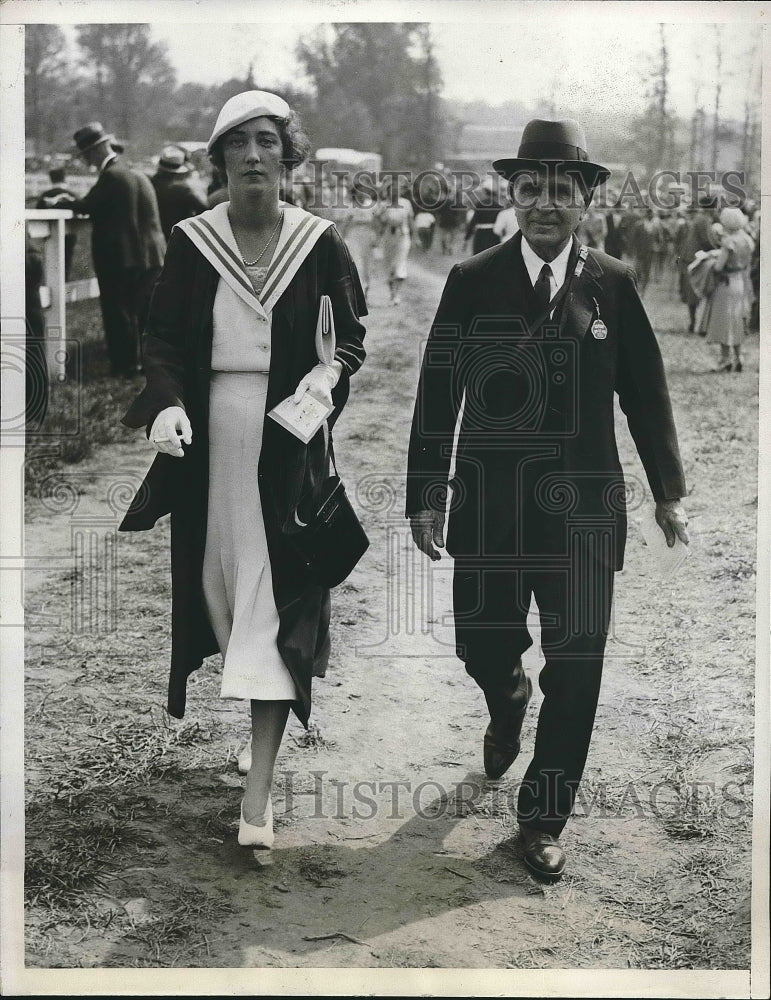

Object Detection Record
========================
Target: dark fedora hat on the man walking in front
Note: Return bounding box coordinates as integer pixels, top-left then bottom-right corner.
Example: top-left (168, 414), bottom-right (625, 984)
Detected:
top-left (493, 118), bottom-right (610, 188)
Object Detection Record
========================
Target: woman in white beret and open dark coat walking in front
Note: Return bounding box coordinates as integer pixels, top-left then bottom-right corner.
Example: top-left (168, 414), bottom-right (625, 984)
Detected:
top-left (121, 91), bottom-right (366, 848)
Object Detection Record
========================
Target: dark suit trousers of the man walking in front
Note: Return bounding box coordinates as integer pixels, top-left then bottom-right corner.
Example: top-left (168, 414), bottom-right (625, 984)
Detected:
top-left (453, 557), bottom-right (613, 835)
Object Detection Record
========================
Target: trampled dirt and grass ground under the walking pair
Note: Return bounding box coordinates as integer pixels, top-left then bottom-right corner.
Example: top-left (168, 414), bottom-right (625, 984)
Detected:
top-left (26, 244), bottom-right (757, 969)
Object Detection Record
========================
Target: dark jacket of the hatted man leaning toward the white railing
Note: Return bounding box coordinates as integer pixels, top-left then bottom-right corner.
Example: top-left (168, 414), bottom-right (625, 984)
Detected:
top-left (72, 159), bottom-right (166, 275)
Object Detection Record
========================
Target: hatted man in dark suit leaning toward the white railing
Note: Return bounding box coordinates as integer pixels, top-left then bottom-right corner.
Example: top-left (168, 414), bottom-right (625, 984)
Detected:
top-left (69, 122), bottom-right (166, 378)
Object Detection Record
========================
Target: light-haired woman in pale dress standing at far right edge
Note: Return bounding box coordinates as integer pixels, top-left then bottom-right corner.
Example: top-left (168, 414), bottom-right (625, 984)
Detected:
top-left (702, 208), bottom-right (755, 372)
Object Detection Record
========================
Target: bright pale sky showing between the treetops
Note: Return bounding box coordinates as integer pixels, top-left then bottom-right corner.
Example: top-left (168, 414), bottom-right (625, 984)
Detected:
top-left (142, 13), bottom-right (759, 118)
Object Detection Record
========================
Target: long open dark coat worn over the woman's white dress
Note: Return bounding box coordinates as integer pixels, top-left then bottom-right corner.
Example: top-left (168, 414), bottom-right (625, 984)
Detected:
top-left (120, 226), bottom-right (367, 726)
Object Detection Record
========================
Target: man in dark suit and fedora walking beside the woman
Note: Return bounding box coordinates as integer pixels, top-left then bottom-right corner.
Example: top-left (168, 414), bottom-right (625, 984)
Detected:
top-left (407, 120), bottom-right (688, 879)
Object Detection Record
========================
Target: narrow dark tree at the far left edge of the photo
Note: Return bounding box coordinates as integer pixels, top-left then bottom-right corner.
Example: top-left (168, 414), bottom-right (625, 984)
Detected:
top-left (24, 24), bottom-right (70, 156)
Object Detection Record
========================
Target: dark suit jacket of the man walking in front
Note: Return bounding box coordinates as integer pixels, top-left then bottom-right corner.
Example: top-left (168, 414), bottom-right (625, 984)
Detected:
top-left (407, 233), bottom-right (685, 569)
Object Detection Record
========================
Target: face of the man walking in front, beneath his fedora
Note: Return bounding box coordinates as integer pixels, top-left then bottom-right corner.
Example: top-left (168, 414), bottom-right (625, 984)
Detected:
top-left (511, 168), bottom-right (586, 260)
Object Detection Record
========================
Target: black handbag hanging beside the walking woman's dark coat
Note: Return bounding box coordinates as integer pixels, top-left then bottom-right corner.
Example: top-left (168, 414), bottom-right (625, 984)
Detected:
top-left (284, 451), bottom-right (369, 587)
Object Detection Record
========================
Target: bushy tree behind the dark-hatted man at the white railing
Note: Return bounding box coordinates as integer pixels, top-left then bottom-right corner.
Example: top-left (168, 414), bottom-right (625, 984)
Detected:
top-left (77, 24), bottom-right (175, 145)
